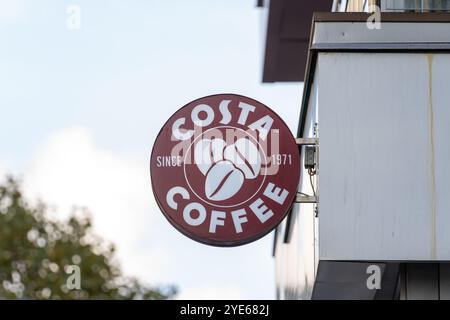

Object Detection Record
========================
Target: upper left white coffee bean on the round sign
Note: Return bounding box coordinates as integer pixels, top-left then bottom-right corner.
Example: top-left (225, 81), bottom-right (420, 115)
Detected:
top-left (194, 138), bottom-right (226, 175)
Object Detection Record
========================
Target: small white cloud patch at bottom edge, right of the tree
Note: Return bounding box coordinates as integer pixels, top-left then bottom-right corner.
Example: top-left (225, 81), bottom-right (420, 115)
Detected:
top-left (176, 286), bottom-right (242, 300)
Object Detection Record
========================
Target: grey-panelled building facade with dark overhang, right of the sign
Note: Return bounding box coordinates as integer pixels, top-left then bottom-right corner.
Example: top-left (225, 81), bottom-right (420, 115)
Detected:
top-left (263, 0), bottom-right (450, 299)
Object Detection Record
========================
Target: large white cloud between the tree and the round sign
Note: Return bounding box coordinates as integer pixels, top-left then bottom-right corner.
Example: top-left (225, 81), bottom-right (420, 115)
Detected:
top-left (24, 128), bottom-right (170, 282)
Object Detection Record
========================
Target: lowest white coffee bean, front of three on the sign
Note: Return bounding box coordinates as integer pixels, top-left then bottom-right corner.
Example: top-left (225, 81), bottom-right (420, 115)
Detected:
top-left (205, 160), bottom-right (245, 201)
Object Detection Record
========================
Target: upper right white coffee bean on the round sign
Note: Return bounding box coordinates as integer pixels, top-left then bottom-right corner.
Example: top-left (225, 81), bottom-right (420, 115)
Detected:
top-left (224, 138), bottom-right (261, 179)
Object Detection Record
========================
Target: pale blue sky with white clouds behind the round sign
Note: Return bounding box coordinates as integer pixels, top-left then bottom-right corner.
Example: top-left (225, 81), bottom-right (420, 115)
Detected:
top-left (0, 0), bottom-right (302, 299)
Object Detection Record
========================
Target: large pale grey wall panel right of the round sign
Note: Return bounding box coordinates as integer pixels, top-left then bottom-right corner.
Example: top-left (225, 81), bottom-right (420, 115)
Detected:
top-left (316, 53), bottom-right (450, 260)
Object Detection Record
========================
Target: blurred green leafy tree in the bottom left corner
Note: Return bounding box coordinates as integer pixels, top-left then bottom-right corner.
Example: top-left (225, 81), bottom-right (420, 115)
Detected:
top-left (0, 178), bottom-right (176, 299)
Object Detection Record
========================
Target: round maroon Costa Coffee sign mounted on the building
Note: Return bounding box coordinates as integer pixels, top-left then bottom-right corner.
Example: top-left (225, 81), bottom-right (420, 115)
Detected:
top-left (150, 94), bottom-right (300, 246)
